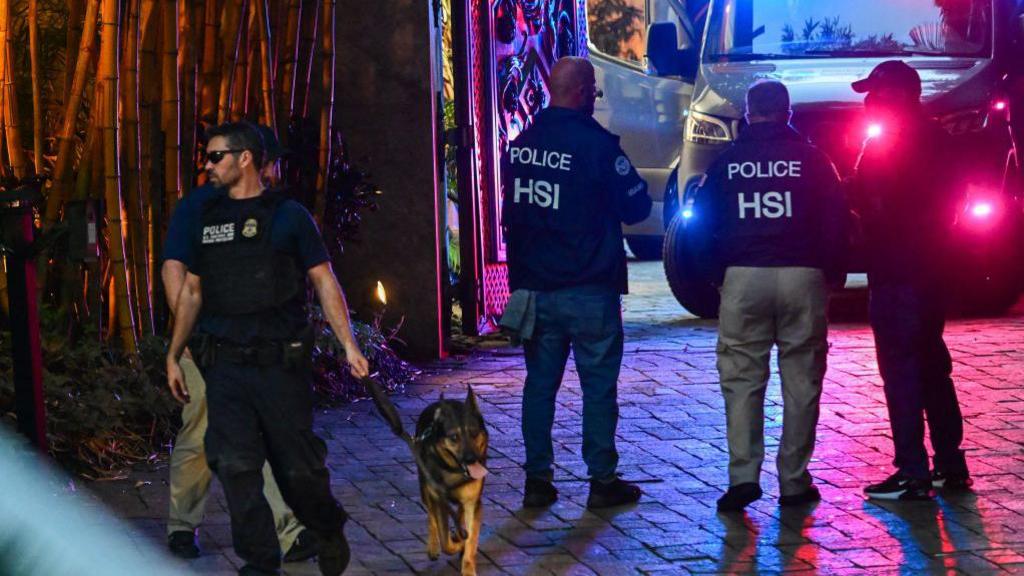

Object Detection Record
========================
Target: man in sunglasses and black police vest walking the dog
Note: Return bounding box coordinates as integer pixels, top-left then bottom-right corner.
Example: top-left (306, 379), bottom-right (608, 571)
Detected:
top-left (167, 123), bottom-right (368, 575)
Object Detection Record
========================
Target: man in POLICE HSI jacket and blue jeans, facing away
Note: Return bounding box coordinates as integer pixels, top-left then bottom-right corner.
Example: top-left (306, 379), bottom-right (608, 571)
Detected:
top-left (502, 57), bottom-right (651, 508)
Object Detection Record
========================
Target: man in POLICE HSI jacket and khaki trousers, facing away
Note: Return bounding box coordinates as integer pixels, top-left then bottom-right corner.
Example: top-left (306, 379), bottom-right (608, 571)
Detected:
top-left (693, 80), bottom-right (848, 511)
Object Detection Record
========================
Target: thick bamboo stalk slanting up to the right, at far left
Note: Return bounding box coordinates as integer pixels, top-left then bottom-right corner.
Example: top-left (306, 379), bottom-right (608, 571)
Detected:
top-left (43, 0), bottom-right (99, 227)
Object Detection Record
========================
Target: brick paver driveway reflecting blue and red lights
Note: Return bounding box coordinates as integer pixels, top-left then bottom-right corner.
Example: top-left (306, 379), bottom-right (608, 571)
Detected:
top-left (94, 263), bottom-right (1024, 575)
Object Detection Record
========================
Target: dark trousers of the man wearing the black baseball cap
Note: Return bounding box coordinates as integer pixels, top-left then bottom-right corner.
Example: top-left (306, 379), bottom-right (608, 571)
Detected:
top-left (868, 278), bottom-right (968, 479)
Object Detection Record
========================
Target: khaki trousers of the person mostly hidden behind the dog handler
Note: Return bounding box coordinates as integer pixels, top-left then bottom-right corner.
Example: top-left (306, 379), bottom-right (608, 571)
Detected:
top-left (167, 358), bottom-right (303, 552)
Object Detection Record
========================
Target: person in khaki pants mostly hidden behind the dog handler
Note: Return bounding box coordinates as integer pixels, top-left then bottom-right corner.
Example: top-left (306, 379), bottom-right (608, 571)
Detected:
top-left (161, 126), bottom-right (317, 562)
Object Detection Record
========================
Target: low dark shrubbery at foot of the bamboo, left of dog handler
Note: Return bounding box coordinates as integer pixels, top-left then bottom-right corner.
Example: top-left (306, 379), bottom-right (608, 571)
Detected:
top-left (0, 308), bottom-right (179, 478)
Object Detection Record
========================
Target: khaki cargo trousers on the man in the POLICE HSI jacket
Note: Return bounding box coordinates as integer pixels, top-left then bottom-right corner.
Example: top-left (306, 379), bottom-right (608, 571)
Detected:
top-left (718, 266), bottom-right (828, 495)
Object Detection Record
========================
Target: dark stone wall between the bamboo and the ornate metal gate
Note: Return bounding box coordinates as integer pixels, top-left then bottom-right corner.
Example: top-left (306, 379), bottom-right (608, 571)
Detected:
top-left (335, 0), bottom-right (442, 358)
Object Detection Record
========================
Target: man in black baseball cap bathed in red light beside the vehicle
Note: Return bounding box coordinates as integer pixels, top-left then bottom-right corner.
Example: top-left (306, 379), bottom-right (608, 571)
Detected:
top-left (850, 60), bottom-right (972, 500)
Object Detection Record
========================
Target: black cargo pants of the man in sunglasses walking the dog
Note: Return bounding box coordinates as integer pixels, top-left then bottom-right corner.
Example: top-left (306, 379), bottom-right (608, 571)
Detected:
top-left (204, 358), bottom-right (347, 572)
